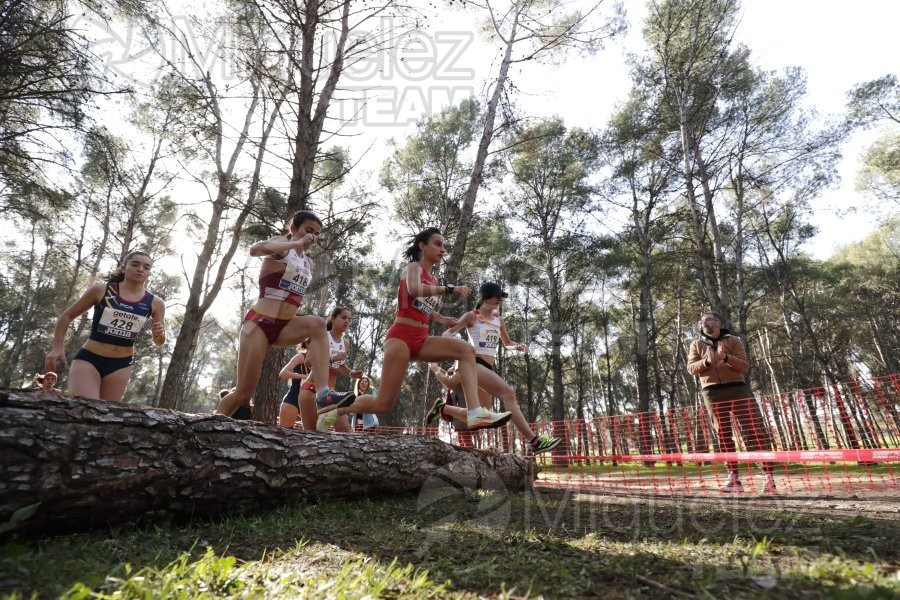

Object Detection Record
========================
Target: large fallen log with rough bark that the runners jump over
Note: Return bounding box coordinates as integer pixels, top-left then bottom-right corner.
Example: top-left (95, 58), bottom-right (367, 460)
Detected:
top-left (0, 389), bottom-right (534, 533)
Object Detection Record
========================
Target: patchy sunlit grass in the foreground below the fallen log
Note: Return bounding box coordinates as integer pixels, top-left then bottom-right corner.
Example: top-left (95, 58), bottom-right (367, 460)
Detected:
top-left (0, 490), bottom-right (900, 600)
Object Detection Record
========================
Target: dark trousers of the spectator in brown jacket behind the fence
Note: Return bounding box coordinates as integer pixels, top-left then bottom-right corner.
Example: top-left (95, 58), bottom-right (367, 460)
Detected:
top-left (701, 384), bottom-right (772, 473)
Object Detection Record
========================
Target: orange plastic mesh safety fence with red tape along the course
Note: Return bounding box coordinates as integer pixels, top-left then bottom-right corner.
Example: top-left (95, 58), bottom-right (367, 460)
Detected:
top-left (344, 374), bottom-right (900, 498)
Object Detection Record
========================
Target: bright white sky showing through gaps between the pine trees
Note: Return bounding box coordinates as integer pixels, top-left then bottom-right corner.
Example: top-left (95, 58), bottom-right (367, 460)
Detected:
top-left (75, 0), bottom-right (900, 282)
